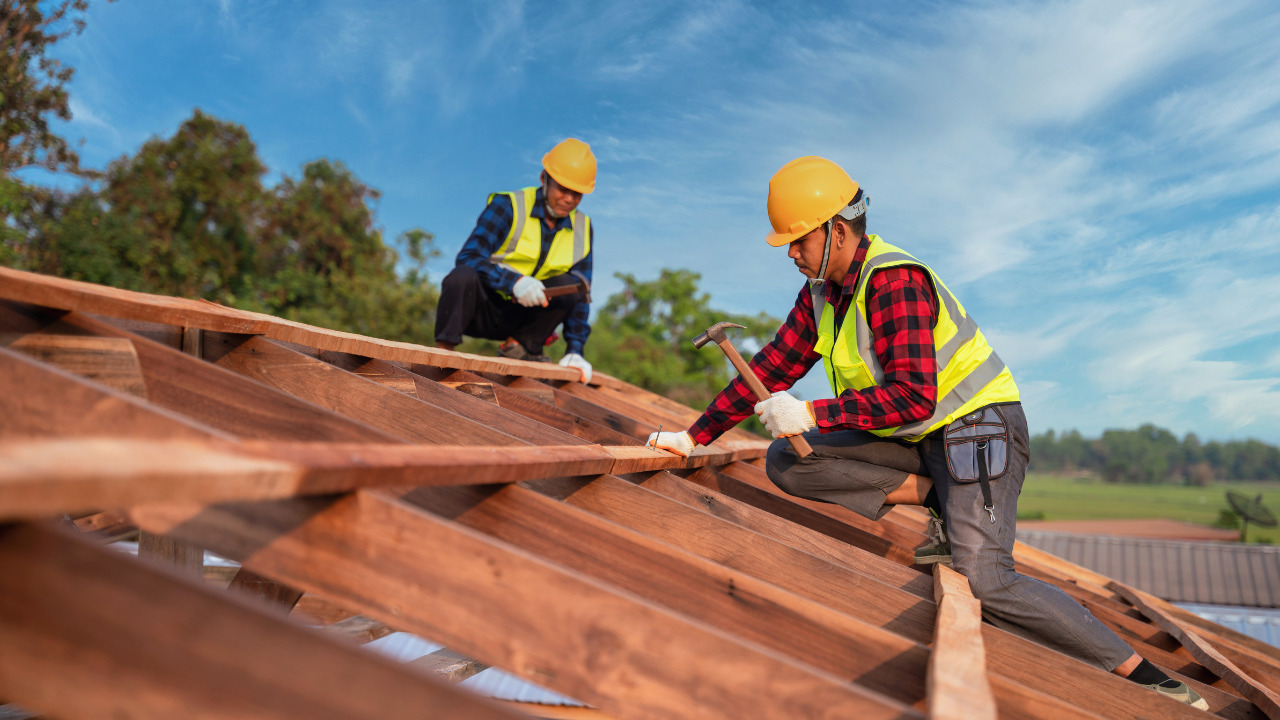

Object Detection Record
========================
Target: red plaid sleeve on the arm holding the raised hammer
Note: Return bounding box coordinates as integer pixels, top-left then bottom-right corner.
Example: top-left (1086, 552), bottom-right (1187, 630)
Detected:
top-left (813, 266), bottom-right (938, 430)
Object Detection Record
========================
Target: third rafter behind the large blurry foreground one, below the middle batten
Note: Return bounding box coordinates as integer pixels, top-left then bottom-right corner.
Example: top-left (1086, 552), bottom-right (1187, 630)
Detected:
top-left (634, 473), bottom-right (933, 600)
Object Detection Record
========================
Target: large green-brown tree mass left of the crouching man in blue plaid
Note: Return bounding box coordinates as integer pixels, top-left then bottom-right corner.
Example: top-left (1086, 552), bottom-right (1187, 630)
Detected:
top-left (0, 110), bottom-right (438, 342)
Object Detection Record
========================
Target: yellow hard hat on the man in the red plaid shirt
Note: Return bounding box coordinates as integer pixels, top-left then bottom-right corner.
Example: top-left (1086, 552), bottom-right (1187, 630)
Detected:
top-left (765, 155), bottom-right (858, 247)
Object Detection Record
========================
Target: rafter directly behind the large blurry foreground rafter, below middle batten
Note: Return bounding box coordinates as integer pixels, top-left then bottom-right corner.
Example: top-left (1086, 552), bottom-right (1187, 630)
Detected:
top-left (404, 480), bottom-right (932, 705)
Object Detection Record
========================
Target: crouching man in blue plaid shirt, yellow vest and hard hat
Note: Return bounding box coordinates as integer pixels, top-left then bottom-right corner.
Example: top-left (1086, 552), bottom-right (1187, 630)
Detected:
top-left (435, 137), bottom-right (595, 383)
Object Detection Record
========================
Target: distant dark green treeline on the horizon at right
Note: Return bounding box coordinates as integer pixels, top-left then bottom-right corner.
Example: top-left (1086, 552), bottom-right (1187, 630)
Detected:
top-left (1030, 424), bottom-right (1280, 486)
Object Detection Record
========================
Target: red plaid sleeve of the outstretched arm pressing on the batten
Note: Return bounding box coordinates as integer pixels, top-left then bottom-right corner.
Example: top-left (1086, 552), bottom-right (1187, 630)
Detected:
top-left (689, 286), bottom-right (819, 445)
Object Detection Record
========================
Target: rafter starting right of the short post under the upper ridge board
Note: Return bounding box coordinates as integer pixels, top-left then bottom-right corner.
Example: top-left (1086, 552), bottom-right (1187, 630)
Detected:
top-left (205, 333), bottom-right (522, 446)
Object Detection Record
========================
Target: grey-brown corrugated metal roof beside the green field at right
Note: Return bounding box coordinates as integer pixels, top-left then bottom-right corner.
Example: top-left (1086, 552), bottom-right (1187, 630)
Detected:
top-left (1018, 528), bottom-right (1280, 607)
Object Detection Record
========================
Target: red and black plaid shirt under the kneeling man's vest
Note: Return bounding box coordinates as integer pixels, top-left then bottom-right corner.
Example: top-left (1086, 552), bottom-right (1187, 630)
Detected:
top-left (689, 236), bottom-right (938, 445)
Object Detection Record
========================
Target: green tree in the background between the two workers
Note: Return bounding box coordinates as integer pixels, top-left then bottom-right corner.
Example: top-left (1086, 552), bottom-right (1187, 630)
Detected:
top-left (590, 269), bottom-right (781, 409)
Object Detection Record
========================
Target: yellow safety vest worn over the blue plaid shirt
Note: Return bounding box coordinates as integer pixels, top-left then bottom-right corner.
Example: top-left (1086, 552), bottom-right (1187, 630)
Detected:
top-left (489, 187), bottom-right (591, 281)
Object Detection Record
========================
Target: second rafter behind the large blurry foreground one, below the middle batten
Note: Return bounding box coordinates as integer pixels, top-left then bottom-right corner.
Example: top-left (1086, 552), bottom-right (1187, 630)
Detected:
top-left (527, 475), bottom-right (936, 644)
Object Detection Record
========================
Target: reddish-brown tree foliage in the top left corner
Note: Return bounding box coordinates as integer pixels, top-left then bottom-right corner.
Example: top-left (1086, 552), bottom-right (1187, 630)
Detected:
top-left (0, 0), bottom-right (98, 174)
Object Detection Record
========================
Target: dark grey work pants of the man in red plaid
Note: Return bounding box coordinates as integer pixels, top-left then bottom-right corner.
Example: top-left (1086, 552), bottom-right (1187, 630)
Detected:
top-left (767, 404), bottom-right (1134, 671)
